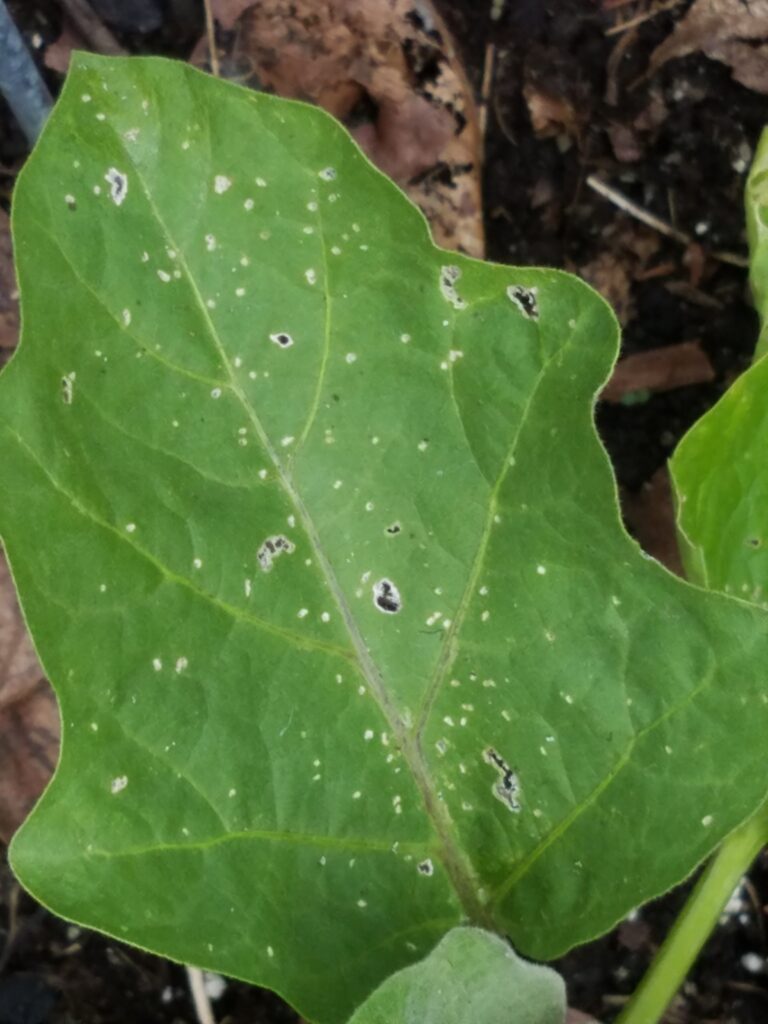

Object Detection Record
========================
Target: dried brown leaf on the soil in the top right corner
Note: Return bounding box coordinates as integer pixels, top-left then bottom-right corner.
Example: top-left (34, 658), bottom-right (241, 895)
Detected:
top-left (649, 0), bottom-right (768, 93)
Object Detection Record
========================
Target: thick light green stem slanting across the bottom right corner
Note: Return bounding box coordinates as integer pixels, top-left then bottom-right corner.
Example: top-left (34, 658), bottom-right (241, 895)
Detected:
top-left (615, 801), bottom-right (768, 1024)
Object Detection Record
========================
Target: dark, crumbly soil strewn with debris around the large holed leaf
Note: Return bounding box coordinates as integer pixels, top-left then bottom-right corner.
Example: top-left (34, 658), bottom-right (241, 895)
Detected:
top-left (0, 0), bottom-right (768, 1024)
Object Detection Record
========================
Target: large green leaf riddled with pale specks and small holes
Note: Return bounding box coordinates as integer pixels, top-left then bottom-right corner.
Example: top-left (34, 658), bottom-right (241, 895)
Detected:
top-left (0, 56), bottom-right (768, 1022)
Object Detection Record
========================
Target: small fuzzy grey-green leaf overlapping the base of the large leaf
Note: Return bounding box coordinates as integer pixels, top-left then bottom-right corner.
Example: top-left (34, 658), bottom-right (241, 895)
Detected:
top-left (349, 928), bottom-right (565, 1024)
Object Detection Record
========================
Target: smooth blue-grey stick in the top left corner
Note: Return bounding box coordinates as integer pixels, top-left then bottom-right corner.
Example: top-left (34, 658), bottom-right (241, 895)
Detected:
top-left (0, 0), bottom-right (53, 145)
